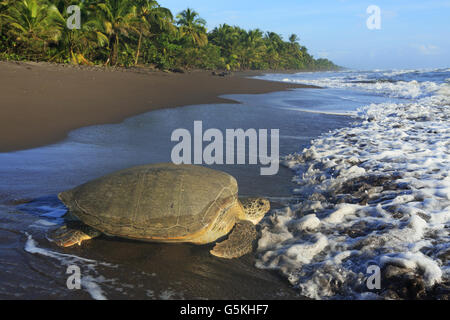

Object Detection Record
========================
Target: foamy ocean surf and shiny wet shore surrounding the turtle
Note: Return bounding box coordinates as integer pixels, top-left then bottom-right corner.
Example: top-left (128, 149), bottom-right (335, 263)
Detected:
top-left (0, 70), bottom-right (450, 299)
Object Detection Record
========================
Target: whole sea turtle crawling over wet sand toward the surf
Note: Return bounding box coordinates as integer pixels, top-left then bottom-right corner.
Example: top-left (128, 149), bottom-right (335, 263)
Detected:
top-left (50, 163), bottom-right (270, 258)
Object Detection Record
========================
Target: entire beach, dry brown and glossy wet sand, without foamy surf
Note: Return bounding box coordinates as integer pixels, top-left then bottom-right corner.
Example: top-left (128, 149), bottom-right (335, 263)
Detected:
top-left (0, 63), bottom-right (349, 300)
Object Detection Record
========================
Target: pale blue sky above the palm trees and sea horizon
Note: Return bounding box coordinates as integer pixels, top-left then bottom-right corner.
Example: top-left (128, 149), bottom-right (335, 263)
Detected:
top-left (159, 0), bottom-right (450, 69)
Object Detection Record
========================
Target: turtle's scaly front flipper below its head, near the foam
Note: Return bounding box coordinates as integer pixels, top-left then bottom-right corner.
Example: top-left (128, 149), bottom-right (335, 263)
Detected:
top-left (210, 220), bottom-right (258, 259)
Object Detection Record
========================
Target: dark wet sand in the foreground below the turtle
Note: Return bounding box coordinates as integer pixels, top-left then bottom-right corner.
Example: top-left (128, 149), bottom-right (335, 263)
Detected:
top-left (0, 199), bottom-right (302, 300)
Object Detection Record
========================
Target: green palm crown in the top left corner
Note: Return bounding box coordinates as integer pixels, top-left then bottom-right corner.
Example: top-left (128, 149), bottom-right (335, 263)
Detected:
top-left (0, 0), bottom-right (61, 58)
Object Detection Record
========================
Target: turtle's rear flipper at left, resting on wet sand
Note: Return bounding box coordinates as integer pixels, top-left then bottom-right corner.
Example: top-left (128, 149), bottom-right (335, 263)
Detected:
top-left (50, 226), bottom-right (101, 248)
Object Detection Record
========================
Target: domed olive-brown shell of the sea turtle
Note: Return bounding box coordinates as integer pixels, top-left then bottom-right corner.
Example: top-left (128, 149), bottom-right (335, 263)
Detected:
top-left (59, 163), bottom-right (238, 242)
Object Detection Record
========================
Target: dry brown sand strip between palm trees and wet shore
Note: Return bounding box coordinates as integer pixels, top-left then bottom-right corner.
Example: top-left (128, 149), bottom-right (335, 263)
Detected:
top-left (0, 62), bottom-right (317, 153)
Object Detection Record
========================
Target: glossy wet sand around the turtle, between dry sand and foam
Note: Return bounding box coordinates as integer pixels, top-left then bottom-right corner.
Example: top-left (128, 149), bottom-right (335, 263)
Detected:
top-left (0, 85), bottom-right (352, 299)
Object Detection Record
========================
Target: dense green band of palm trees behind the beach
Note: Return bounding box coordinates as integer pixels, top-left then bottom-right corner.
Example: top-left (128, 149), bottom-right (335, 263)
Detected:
top-left (0, 0), bottom-right (337, 70)
